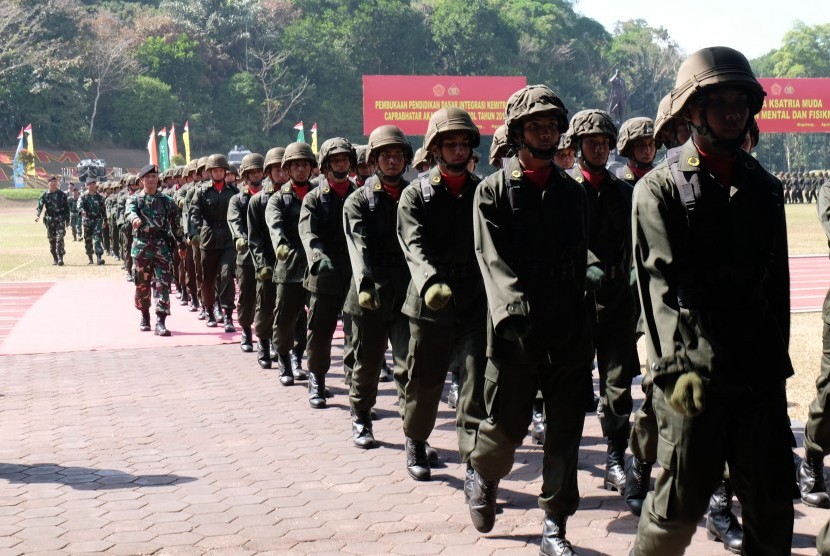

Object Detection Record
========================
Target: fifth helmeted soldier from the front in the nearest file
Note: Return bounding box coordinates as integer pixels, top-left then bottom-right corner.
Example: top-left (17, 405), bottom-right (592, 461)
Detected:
top-left (299, 137), bottom-right (357, 409)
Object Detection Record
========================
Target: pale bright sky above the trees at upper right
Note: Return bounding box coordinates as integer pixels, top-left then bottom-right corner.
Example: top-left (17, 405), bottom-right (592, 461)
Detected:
top-left (574, 0), bottom-right (830, 59)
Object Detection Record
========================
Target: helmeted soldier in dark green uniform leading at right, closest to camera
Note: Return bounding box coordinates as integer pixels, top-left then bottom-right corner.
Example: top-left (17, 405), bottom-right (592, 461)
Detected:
top-left (632, 47), bottom-right (795, 556)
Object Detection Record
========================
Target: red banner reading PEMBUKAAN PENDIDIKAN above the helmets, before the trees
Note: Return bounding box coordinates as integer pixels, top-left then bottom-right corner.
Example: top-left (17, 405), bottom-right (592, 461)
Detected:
top-left (363, 75), bottom-right (527, 135)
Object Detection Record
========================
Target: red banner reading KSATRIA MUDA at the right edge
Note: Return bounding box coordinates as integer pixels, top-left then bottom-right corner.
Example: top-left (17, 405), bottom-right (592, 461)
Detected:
top-left (756, 77), bottom-right (830, 133)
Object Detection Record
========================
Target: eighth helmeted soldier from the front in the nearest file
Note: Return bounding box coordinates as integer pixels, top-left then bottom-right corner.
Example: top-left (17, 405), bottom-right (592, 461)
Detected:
top-left (228, 153), bottom-right (264, 353)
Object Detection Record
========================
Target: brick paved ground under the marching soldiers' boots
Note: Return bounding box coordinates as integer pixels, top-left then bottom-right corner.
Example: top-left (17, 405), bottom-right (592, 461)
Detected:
top-left (0, 345), bottom-right (830, 556)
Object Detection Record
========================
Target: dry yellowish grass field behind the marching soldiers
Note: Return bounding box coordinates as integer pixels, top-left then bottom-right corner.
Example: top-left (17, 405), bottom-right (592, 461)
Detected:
top-left (0, 200), bottom-right (827, 421)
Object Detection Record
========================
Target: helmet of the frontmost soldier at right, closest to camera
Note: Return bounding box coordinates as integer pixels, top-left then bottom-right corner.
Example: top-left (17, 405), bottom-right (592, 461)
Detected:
top-left (669, 46), bottom-right (766, 116)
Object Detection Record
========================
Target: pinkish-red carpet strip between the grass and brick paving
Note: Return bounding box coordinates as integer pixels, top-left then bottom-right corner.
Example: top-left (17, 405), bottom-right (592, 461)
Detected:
top-left (0, 280), bottom-right (240, 355)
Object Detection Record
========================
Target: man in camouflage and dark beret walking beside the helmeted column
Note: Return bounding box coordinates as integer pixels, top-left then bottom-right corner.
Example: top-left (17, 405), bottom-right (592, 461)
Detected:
top-left (124, 164), bottom-right (184, 336)
